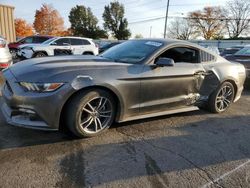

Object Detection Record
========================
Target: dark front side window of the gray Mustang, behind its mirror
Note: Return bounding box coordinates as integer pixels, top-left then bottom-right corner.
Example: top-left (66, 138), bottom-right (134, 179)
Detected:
top-left (160, 47), bottom-right (200, 63)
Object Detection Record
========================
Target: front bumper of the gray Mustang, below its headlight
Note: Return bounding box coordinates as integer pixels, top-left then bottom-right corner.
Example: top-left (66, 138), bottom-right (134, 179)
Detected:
top-left (1, 70), bottom-right (73, 130)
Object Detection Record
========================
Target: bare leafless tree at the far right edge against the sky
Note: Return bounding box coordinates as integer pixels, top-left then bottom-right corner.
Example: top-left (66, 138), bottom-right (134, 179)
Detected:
top-left (225, 0), bottom-right (250, 38)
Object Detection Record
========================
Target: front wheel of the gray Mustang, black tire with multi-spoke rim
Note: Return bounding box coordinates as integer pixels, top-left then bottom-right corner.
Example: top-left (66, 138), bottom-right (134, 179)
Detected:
top-left (66, 89), bottom-right (116, 138)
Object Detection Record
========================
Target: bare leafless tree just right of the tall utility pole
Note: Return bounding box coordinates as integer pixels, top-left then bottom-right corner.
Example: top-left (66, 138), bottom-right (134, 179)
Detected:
top-left (168, 18), bottom-right (194, 40)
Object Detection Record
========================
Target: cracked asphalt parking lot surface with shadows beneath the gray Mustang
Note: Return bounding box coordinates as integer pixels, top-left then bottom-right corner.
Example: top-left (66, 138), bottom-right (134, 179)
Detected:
top-left (0, 73), bottom-right (250, 188)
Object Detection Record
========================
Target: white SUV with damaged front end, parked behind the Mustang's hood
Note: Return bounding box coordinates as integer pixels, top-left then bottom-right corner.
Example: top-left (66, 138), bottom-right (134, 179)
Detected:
top-left (17, 37), bottom-right (99, 59)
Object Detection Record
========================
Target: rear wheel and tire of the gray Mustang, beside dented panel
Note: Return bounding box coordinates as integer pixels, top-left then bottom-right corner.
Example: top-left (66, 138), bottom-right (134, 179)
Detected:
top-left (208, 82), bottom-right (235, 113)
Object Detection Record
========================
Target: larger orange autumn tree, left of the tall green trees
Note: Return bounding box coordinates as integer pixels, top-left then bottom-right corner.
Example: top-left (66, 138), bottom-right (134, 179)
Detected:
top-left (33, 4), bottom-right (65, 36)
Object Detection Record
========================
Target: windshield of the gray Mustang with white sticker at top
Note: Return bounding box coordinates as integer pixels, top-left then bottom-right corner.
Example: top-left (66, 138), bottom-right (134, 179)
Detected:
top-left (101, 40), bottom-right (163, 64)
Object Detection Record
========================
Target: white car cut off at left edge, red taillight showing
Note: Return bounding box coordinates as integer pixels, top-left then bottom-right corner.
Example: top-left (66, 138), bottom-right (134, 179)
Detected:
top-left (0, 36), bottom-right (13, 71)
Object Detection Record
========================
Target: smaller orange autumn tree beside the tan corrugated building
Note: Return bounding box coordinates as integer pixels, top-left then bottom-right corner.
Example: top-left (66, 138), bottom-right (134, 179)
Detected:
top-left (15, 18), bottom-right (34, 37)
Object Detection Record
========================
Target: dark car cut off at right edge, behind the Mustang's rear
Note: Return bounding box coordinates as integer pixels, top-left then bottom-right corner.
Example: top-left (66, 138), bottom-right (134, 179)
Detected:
top-left (225, 46), bottom-right (250, 78)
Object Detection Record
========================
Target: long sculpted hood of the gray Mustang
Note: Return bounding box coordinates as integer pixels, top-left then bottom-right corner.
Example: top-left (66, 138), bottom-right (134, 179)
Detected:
top-left (9, 55), bottom-right (129, 82)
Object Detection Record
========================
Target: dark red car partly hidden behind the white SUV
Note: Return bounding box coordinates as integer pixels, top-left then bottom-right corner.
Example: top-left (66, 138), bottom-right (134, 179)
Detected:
top-left (8, 35), bottom-right (52, 58)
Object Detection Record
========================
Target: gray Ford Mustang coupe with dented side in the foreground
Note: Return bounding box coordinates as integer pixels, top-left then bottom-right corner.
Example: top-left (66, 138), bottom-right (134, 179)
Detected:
top-left (1, 39), bottom-right (246, 137)
